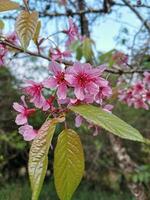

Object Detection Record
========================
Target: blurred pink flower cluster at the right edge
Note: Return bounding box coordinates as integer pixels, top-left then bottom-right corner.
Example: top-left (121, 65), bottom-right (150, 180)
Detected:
top-left (119, 72), bottom-right (150, 110)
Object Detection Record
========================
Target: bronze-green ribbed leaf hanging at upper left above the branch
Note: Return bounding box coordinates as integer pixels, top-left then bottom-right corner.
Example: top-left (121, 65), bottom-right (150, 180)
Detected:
top-left (16, 11), bottom-right (38, 50)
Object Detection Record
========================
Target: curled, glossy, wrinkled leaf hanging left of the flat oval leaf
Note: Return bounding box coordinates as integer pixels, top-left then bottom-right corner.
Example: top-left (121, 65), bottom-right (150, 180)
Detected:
top-left (28, 115), bottom-right (64, 200)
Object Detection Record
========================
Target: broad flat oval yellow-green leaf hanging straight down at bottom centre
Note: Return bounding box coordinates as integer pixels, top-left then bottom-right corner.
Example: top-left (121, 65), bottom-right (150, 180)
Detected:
top-left (54, 129), bottom-right (84, 200)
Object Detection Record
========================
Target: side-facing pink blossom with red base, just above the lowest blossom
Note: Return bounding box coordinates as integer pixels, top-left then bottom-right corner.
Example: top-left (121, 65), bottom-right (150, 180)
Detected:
top-left (13, 96), bottom-right (35, 125)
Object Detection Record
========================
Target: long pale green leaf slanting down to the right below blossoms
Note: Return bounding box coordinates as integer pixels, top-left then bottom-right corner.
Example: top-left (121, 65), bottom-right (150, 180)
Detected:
top-left (70, 105), bottom-right (145, 142)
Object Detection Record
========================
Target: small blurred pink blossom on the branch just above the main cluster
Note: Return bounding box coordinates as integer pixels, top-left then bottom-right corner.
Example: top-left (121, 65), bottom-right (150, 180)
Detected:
top-left (50, 48), bottom-right (71, 61)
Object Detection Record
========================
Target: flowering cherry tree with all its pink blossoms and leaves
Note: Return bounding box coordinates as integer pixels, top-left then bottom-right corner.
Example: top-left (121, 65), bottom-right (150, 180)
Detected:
top-left (0, 0), bottom-right (150, 200)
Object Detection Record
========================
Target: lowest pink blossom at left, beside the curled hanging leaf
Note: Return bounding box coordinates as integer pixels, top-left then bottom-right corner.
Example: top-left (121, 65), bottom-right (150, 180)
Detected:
top-left (19, 124), bottom-right (37, 141)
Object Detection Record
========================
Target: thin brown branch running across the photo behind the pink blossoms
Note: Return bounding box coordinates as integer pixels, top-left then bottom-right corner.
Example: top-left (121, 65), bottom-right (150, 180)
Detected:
top-left (0, 39), bottom-right (150, 75)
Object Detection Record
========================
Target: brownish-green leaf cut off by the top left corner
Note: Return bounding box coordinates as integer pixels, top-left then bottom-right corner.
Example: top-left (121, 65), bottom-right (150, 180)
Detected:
top-left (0, 0), bottom-right (20, 12)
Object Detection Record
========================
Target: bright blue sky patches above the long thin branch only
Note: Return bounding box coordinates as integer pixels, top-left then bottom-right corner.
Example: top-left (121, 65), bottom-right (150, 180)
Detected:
top-left (0, 0), bottom-right (150, 54)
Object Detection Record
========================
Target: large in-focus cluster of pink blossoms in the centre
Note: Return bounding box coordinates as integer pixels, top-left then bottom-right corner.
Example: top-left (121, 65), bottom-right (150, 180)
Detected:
top-left (13, 61), bottom-right (112, 140)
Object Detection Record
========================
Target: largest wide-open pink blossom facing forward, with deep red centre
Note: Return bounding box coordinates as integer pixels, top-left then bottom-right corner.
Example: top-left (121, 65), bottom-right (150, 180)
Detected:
top-left (65, 62), bottom-right (105, 101)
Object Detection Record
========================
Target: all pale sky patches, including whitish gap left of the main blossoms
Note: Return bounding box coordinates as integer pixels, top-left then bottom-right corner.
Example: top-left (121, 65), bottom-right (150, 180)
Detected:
top-left (0, 0), bottom-right (150, 80)
